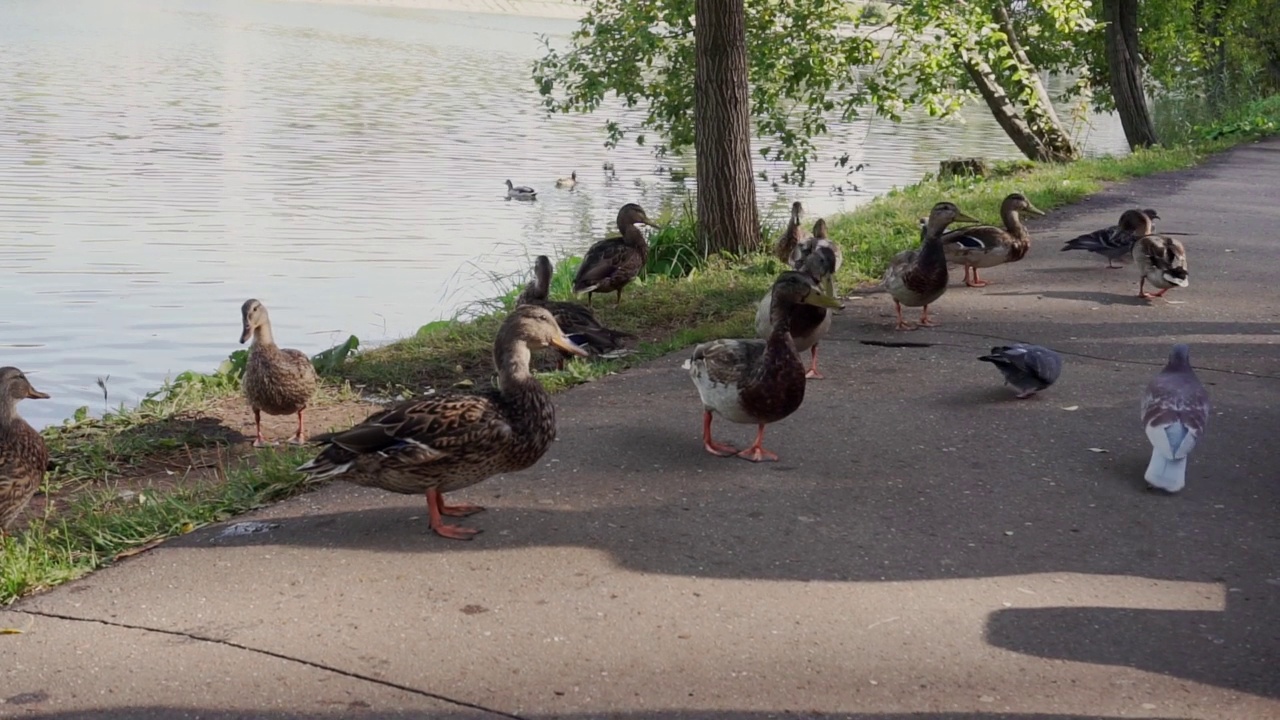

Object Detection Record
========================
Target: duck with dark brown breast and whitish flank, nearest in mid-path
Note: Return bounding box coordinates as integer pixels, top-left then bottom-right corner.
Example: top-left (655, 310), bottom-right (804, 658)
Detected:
top-left (685, 272), bottom-right (840, 462)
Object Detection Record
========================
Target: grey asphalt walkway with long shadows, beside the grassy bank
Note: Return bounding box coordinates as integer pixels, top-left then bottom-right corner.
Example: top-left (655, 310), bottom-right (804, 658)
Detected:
top-left (0, 141), bottom-right (1280, 720)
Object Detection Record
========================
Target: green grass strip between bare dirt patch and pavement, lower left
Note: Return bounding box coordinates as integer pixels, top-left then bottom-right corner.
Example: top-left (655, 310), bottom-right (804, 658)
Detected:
top-left (0, 448), bottom-right (310, 606)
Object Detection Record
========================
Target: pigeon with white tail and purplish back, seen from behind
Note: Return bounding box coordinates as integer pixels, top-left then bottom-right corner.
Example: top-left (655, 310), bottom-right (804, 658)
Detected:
top-left (1142, 345), bottom-right (1210, 492)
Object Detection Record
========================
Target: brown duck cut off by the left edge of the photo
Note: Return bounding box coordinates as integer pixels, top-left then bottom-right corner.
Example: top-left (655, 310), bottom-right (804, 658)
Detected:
top-left (0, 368), bottom-right (49, 534)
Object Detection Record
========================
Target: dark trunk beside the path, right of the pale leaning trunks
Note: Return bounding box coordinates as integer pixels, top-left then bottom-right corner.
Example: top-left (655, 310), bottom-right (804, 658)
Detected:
top-left (1102, 0), bottom-right (1160, 150)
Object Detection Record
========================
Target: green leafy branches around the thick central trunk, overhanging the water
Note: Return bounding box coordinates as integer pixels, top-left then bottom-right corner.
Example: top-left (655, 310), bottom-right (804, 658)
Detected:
top-left (532, 0), bottom-right (1092, 183)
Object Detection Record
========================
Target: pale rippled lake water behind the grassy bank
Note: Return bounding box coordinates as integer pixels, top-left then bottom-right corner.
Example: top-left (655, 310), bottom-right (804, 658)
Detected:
top-left (0, 0), bottom-right (1125, 425)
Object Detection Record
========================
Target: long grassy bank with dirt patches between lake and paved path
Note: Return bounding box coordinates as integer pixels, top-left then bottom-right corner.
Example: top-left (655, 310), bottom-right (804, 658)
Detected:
top-left (0, 99), bottom-right (1280, 605)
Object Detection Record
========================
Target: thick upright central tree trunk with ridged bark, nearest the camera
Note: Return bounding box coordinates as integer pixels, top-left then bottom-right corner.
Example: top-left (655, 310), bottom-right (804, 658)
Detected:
top-left (694, 0), bottom-right (760, 254)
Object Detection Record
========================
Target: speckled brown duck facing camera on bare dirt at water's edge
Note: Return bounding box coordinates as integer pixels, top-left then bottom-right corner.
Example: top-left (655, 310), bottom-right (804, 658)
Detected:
top-left (241, 299), bottom-right (316, 447)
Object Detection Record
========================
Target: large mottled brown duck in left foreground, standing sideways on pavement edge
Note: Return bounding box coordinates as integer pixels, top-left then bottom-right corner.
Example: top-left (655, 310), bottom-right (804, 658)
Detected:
top-left (298, 305), bottom-right (586, 539)
